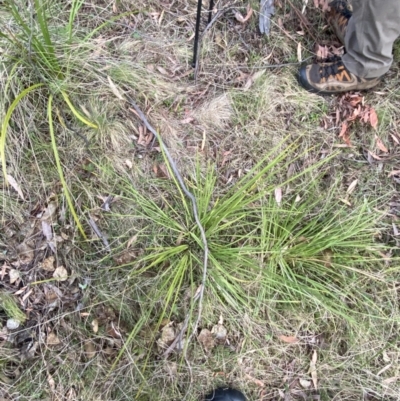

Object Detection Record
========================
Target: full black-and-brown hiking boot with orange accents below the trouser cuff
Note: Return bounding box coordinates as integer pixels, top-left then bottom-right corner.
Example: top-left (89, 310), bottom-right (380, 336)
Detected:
top-left (298, 57), bottom-right (380, 95)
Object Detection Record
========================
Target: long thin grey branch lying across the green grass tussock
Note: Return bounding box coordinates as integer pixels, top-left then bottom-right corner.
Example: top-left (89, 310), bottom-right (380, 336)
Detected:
top-left (127, 98), bottom-right (209, 356)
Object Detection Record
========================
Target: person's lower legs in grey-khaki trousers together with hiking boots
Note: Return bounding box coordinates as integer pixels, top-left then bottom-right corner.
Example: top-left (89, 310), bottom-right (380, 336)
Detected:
top-left (298, 0), bottom-right (400, 94)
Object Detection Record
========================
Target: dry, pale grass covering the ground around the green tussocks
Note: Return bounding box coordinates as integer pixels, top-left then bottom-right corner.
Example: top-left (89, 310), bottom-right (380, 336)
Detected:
top-left (0, 0), bottom-right (400, 401)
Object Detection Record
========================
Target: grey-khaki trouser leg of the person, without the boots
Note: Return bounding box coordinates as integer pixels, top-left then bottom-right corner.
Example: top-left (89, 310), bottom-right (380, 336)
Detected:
top-left (342, 0), bottom-right (400, 78)
